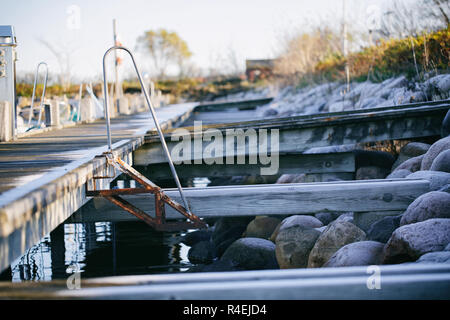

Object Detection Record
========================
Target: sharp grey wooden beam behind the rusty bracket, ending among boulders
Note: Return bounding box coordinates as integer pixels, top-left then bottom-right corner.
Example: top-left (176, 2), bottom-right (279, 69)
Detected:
top-left (68, 179), bottom-right (429, 222)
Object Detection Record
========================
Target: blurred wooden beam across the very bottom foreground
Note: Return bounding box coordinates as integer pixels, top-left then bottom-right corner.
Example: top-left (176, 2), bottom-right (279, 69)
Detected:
top-left (0, 264), bottom-right (450, 300)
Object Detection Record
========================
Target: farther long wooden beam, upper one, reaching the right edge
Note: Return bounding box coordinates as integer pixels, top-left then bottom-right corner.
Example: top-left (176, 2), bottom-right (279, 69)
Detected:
top-left (134, 103), bottom-right (450, 165)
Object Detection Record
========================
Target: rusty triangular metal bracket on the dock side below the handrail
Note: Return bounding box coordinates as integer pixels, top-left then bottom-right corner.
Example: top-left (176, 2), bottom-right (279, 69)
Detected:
top-left (86, 152), bottom-right (207, 231)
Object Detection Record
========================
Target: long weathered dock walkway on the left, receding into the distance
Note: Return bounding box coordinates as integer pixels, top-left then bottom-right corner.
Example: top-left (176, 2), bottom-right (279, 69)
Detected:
top-left (0, 104), bottom-right (196, 270)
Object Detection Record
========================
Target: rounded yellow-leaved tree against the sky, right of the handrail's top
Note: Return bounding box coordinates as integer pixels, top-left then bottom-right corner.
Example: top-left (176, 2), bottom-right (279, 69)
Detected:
top-left (137, 29), bottom-right (192, 78)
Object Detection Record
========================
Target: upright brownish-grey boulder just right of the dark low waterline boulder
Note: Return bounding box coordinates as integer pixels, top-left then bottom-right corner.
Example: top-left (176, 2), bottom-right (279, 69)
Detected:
top-left (276, 225), bottom-right (320, 269)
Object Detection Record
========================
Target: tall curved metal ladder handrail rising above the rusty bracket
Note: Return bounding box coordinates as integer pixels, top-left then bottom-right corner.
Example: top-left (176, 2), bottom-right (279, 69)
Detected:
top-left (103, 46), bottom-right (191, 213)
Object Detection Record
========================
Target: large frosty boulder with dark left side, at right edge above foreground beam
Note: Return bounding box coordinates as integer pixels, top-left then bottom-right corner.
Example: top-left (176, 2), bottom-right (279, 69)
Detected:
top-left (383, 219), bottom-right (450, 264)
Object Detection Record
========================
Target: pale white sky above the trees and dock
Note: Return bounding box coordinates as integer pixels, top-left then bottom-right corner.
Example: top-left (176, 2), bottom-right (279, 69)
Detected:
top-left (0, 0), bottom-right (400, 79)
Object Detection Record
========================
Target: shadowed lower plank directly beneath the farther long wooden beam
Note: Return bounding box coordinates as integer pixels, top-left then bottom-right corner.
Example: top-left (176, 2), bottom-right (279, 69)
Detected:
top-left (134, 152), bottom-right (355, 179)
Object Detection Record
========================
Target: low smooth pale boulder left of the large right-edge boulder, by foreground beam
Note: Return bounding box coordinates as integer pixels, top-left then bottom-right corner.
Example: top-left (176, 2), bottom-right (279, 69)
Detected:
top-left (323, 241), bottom-right (384, 268)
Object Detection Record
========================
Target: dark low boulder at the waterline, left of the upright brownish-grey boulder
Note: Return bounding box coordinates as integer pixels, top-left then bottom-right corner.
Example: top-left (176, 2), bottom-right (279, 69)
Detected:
top-left (221, 238), bottom-right (278, 270)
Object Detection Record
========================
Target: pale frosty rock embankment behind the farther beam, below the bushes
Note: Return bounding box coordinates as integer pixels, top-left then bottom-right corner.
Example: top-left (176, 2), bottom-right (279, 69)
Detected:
top-left (258, 74), bottom-right (450, 119)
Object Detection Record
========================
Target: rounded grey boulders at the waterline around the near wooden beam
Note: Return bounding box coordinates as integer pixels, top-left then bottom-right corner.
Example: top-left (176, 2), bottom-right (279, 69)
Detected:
top-left (182, 111), bottom-right (450, 272)
